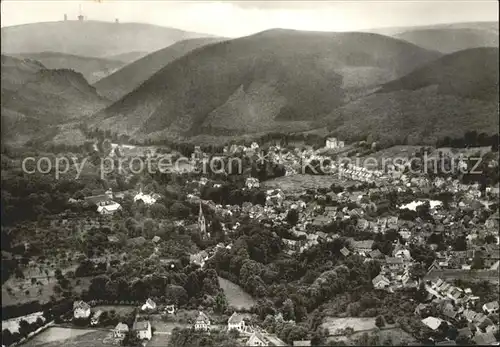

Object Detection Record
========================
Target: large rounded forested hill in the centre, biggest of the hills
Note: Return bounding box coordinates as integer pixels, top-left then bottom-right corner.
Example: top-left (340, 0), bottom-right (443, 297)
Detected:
top-left (92, 29), bottom-right (440, 140)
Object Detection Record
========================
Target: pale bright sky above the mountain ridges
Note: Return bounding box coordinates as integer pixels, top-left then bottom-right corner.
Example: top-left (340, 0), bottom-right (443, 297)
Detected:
top-left (1, 0), bottom-right (498, 37)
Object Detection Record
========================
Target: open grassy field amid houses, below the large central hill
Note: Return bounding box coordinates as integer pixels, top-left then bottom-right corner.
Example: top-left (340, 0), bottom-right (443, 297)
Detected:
top-left (262, 174), bottom-right (355, 194)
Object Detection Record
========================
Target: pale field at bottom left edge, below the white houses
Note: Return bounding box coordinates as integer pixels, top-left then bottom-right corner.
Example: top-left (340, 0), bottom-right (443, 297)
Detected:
top-left (23, 327), bottom-right (112, 347)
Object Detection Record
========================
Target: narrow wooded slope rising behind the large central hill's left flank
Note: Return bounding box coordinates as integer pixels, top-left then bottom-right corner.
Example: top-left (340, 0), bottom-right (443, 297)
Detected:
top-left (94, 38), bottom-right (227, 101)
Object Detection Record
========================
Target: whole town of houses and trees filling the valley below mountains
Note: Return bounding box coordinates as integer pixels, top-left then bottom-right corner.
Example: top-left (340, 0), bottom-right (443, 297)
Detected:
top-left (2, 137), bottom-right (500, 346)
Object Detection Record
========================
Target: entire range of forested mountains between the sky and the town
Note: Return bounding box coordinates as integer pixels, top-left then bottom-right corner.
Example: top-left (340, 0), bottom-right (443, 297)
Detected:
top-left (1, 21), bottom-right (498, 150)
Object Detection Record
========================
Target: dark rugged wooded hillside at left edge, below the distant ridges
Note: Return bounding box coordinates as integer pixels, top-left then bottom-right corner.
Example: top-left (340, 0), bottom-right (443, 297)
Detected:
top-left (1, 66), bottom-right (109, 143)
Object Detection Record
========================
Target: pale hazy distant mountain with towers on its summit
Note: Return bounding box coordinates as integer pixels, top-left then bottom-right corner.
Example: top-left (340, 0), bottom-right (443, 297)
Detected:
top-left (1, 21), bottom-right (208, 57)
